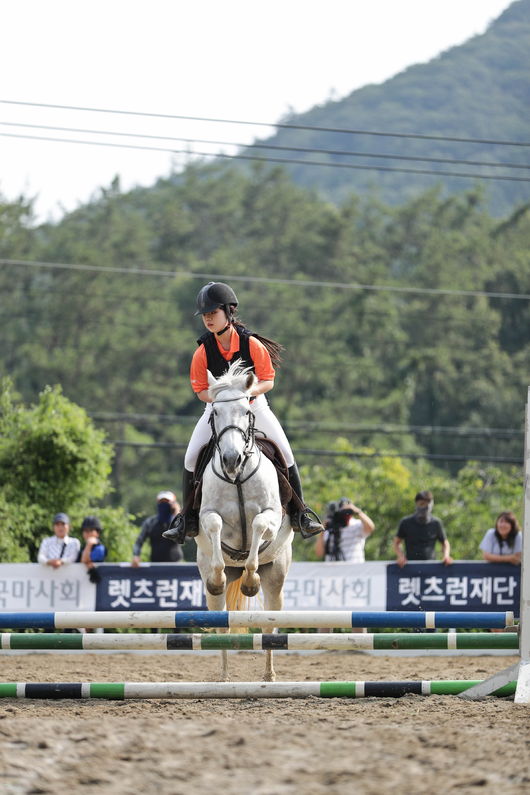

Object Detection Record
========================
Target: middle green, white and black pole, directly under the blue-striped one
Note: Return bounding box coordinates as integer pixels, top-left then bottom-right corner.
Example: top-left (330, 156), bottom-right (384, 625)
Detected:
top-left (0, 632), bottom-right (519, 651)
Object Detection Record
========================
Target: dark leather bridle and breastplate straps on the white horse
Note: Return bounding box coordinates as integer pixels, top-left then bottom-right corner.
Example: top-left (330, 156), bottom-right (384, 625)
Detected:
top-left (208, 387), bottom-right (271, 560)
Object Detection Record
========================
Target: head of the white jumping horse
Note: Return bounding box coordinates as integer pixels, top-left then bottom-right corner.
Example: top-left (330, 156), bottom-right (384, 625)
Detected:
top-left (208, 362), bottom-right (257, 481)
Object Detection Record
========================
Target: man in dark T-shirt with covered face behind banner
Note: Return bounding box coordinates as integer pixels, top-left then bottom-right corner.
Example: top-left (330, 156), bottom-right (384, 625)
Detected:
top-left (394, 491), bottom-right (453, 567)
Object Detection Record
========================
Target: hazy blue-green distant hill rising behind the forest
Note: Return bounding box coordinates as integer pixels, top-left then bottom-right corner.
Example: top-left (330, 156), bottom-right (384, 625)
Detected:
top-left (244, 0), bottom-right (530, 215)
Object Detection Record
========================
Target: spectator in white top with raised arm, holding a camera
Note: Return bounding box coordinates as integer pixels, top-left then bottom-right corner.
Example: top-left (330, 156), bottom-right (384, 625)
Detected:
top-left (315, 497), bottom-right (375, 563)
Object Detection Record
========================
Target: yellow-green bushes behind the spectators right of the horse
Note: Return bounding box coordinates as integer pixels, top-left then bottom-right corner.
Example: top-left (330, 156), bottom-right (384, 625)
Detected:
top-left (295, 439), bottom-right (523, 560)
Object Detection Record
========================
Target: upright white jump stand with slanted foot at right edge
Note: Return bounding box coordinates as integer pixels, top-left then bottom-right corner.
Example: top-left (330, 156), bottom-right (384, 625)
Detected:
top-left (460, 387), bottom-right (530, 704)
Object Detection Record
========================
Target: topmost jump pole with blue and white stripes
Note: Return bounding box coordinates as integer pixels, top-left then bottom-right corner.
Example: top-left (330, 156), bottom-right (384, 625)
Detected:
top-left (0, 610), bottom-right (514, 629)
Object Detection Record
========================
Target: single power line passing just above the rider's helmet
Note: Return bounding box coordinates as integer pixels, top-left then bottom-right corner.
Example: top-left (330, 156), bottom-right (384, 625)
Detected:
top-left (0, 258), bottom-right (530, 301)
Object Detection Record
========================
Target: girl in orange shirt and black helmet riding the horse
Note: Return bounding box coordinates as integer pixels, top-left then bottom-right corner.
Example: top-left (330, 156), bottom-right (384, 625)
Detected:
top-left (163, 282), bottom-right (323, 543)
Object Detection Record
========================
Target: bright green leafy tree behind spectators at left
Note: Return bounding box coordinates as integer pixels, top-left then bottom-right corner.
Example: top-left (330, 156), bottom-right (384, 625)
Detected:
top-left (0, 379), bottom-right (135, 561)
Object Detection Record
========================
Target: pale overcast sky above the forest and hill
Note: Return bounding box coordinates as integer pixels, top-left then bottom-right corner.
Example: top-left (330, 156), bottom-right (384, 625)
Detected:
top-left (0, 0), bottom-right (511, 220)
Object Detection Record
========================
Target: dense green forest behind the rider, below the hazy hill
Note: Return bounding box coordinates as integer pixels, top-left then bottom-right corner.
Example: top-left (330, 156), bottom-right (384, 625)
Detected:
top-left (0, 159), bottom-right (530, 559)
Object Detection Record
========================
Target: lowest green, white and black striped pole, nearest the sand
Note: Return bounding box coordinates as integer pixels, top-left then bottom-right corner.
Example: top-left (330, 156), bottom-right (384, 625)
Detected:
top-left (0, 680), bottom-right (516, 700)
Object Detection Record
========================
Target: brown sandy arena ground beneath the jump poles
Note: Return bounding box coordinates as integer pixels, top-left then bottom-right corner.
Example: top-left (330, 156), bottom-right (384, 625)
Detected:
top-left (0, 652), bottom-right (530, 795)
